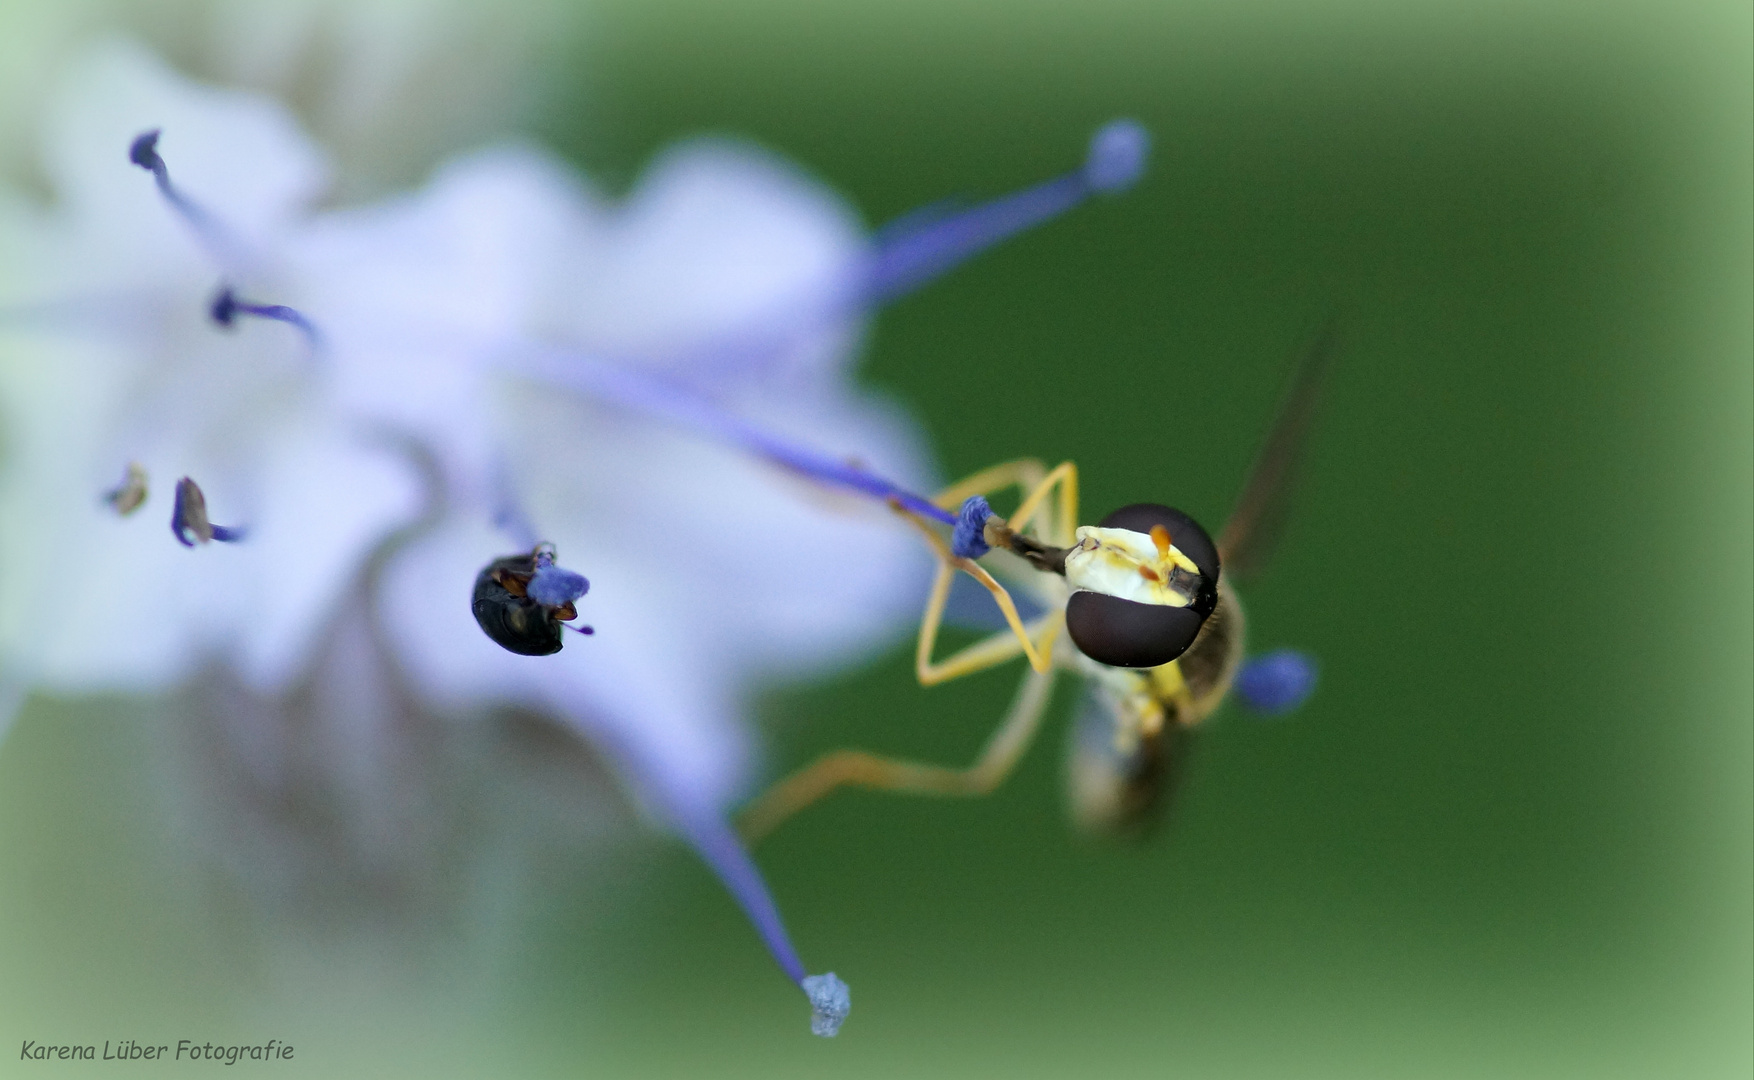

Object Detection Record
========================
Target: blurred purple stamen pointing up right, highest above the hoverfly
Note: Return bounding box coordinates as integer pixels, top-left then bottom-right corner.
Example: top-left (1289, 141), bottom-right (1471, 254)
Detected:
top-left (865, 119), bottom-right (1151, 302)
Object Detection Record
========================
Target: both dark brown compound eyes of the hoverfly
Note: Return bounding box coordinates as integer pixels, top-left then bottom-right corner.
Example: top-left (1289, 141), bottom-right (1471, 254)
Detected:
top-left (1066, 503), bottom-right (1219, 668)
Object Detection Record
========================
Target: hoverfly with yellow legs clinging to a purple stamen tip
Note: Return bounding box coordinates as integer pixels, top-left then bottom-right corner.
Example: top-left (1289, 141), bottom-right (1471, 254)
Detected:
top-left (738, 328), bottom-right (1335, 842)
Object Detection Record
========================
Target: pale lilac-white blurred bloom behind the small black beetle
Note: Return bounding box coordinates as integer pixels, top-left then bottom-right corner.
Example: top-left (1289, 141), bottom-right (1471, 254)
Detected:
top-left (280, 135), bottom-right (924, 803)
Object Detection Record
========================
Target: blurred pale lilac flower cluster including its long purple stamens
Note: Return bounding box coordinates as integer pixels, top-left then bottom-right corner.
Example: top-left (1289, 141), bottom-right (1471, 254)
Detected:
top-left (0, 44), bottom-right (1144, 1034)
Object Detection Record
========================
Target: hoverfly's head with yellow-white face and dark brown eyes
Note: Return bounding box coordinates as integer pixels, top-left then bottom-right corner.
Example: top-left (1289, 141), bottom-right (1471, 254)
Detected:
top-left (1066, 503), bottom-right (1219, 668)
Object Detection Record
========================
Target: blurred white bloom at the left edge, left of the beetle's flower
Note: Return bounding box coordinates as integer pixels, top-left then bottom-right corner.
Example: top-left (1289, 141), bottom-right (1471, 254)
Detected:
top-left (0, 37), bottom-right (391, 691)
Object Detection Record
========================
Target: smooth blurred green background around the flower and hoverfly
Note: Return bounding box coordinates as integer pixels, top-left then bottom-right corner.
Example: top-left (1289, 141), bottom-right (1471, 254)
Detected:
top-left (0, 0), bottom-right (1754, 1076)
